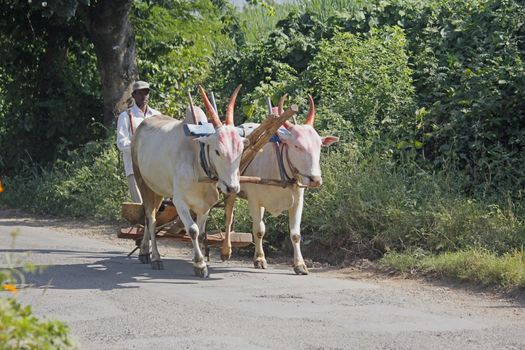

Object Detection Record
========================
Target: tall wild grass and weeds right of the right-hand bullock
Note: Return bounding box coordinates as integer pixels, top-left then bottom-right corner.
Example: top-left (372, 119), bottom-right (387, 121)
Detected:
top-left (296, 147), bottom-right (525, 261)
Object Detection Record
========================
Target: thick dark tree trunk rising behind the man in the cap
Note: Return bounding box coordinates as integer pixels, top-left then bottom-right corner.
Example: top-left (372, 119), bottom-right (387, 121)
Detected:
top-left (78, 0), bottom-right (138, 127)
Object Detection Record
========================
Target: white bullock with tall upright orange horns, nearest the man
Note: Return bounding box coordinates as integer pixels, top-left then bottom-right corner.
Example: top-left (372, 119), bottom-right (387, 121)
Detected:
top-left (131, 86), bottom-right (247, 277)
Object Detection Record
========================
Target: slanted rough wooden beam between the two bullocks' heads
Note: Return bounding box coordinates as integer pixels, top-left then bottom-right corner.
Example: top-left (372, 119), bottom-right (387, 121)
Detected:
top-left (239, 105), bottom-right (299, 175)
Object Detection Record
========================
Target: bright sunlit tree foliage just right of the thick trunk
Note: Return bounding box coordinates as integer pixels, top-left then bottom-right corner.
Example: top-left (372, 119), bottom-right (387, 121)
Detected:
top-left (131, 0), bottom-right (232, 116)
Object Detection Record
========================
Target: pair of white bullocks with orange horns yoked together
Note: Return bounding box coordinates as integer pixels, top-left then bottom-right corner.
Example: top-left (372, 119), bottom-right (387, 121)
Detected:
top-left (131, 86), bottom-right (337, 277)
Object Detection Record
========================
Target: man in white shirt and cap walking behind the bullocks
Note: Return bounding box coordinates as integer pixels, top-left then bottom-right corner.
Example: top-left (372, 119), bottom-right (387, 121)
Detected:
top-left (117, 81), bottom-right (161, 203)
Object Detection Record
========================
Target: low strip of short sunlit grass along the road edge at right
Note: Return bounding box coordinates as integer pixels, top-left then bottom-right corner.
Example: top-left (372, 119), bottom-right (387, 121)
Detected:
top-left (380, 249), bottom-right (525, 289)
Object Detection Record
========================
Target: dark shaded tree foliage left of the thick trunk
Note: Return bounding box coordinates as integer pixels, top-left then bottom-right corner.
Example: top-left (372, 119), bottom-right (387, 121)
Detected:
top-left (0, 1), bottom-right (104, 173)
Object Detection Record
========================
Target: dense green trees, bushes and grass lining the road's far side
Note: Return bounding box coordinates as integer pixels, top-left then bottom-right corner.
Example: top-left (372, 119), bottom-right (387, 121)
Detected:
top-left (0, 0), bottom-right (525, 285)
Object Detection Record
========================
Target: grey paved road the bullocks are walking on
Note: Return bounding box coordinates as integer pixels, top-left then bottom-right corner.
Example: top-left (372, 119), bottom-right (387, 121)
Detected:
top-left (0, 211), bottom-right (525, 349)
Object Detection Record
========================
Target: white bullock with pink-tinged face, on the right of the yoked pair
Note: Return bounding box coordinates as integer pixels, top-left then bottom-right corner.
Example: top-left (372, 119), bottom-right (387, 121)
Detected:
top-left (221, 95), bottom-right (338, 275)
